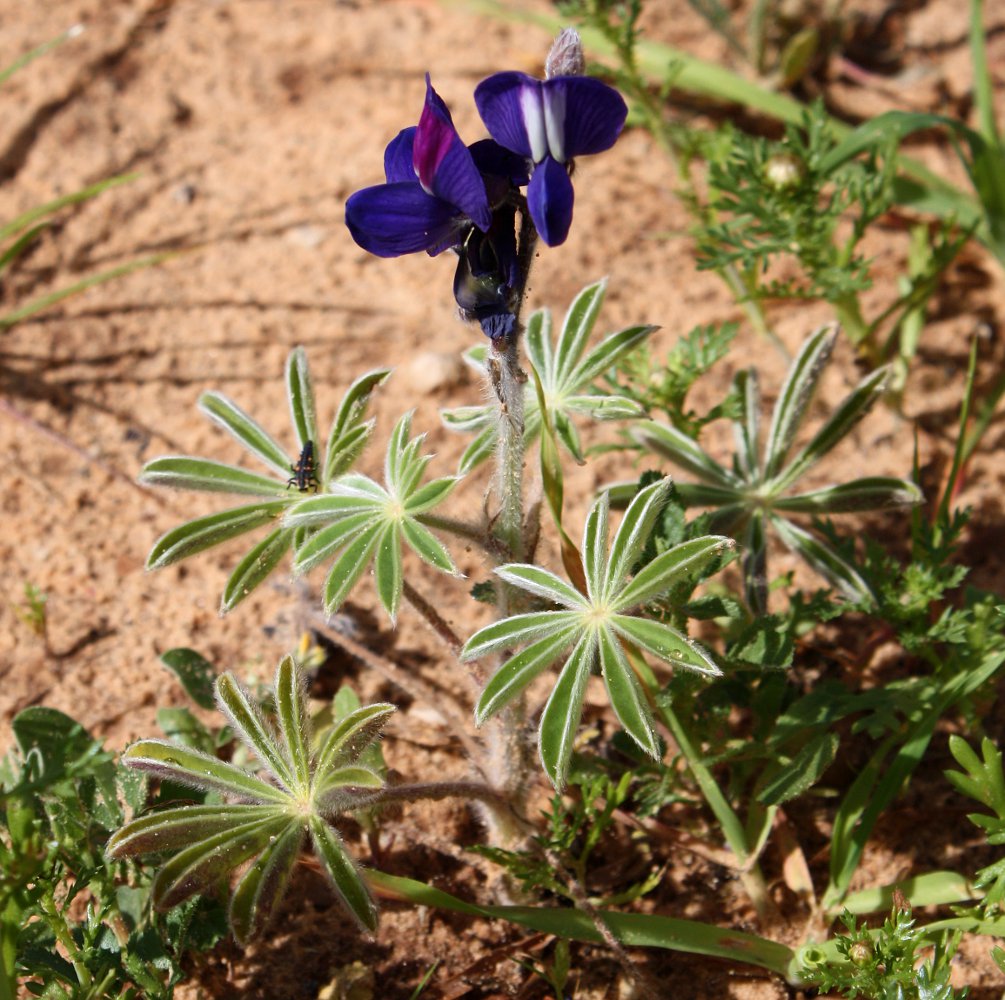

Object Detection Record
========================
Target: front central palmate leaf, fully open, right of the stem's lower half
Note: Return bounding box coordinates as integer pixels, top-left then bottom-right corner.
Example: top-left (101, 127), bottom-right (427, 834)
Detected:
top-left (461, 479), bottom-right (733, 788)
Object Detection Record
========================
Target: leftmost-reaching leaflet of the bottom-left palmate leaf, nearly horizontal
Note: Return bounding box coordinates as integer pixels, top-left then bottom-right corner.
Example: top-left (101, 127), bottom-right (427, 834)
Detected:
top-left (106, 803), bottom-right (277, 857)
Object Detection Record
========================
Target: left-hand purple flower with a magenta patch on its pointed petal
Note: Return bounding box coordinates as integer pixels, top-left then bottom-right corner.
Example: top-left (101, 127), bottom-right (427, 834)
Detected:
top-left (346, 73), bottom-right (492, 257)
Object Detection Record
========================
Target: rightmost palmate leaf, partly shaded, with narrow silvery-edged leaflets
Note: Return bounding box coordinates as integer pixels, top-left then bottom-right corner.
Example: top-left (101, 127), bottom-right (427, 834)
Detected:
top-left (631, 327), bottom-right (923, 613)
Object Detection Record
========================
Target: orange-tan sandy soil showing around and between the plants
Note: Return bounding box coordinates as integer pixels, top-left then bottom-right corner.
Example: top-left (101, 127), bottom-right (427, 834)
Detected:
top-left (0, 0), bottom-right (1005, 1000)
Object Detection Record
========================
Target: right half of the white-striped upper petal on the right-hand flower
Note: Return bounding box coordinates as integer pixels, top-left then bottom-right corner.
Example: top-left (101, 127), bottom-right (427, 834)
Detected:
top-left (542, 76), bottom-right (628, 162)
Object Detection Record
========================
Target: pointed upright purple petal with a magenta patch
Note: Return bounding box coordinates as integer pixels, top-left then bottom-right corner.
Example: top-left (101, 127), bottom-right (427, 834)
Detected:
top-left (412, 74), bottom-right (491, 231)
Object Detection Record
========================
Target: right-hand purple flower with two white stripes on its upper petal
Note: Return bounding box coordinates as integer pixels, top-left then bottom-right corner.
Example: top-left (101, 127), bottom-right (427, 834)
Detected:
top-left (474, 72), bottom-right (628, 246)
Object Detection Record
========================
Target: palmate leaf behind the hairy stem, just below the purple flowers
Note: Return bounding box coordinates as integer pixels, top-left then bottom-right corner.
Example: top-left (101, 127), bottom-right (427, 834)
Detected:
top-left (440, 278), bottom-right (659, 475)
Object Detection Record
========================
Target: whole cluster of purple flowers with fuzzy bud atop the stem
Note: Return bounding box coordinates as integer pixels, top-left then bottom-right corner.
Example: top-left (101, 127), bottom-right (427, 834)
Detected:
top-left (346, 32), bottom-right (627, 341)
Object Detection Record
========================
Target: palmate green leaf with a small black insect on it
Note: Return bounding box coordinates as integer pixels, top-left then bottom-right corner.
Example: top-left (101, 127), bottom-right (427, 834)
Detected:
top-left (140, 348), bottom-right (389, 614)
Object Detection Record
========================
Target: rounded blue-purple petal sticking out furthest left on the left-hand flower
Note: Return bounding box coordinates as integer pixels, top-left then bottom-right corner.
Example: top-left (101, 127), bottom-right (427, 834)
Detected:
top-left (346, 181), bottom-right (464, 257)
